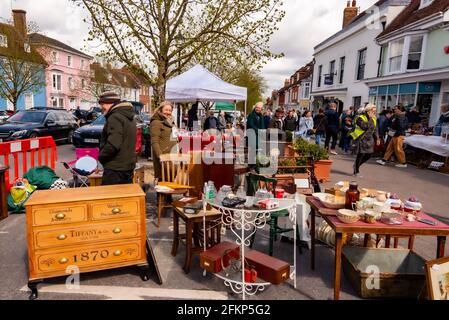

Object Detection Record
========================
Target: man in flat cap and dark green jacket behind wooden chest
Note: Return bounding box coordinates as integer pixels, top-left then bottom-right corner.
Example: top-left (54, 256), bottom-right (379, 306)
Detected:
top-left (98, 92), bottom-right (137, 186)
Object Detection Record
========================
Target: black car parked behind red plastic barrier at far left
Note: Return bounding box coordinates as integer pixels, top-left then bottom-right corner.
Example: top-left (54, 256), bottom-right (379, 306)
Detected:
top-left (0, 108), bottom-right (78, 143)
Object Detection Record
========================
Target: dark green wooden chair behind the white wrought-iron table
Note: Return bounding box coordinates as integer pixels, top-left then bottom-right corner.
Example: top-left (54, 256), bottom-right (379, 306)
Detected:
top-left (248, 173), bottom-right (302, 256)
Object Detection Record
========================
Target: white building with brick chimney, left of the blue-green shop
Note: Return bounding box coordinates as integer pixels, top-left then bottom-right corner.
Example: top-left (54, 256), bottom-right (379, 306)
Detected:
top-left (312, 0), bottom-right (410, 112)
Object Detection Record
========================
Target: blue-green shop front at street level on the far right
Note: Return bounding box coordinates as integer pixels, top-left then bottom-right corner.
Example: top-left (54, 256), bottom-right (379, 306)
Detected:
top-left (369, 81), bottom-right (448, 126)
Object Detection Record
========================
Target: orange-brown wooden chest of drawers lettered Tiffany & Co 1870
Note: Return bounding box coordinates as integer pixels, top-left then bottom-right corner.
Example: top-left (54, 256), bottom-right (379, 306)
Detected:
top-left (26, 184), bottom-right (148, 298)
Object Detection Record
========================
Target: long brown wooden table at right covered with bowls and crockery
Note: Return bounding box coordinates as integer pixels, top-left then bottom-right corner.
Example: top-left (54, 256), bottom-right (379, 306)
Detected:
top-left (307, 197), bottom-right (449, 300)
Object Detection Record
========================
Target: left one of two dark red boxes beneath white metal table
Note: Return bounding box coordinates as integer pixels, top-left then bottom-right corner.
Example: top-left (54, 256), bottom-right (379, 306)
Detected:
top-left (200, 241), bottom-right (240, 273)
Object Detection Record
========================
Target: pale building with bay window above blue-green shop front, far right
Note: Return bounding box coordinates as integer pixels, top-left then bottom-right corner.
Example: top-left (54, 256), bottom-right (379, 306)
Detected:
top-left (365, 0), bottom-right (449, 127)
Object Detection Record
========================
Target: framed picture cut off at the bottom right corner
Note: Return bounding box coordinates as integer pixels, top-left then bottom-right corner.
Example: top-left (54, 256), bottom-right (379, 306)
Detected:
top-left (426, 257), bottom-right (449, 301)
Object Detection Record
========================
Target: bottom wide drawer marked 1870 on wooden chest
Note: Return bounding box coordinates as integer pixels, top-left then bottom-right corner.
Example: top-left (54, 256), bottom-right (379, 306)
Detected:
top-left (35, 240), bottom-right (145, 273)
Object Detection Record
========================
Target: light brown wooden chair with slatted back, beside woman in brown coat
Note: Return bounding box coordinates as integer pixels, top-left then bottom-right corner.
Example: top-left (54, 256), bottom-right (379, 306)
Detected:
top-left (157, 154), bottom-right (190, 228)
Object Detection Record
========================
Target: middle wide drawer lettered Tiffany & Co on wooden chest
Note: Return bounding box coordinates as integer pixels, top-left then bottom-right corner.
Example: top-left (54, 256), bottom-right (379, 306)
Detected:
top-left (34, 220), bottom-right (141, 249)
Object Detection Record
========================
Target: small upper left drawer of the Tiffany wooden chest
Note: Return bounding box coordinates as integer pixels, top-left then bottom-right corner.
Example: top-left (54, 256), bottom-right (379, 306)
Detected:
top-left (31, 203), bottom-right (88, 226)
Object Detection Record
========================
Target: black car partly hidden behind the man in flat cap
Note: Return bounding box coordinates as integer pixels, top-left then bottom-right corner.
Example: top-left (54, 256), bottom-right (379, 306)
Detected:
top-left (73, 115), bottom-right (143, 148)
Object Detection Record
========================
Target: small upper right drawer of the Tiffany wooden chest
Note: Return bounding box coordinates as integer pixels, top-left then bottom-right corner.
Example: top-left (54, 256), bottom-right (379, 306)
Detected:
top-left (90, 198), bottom-right (140, 221)
